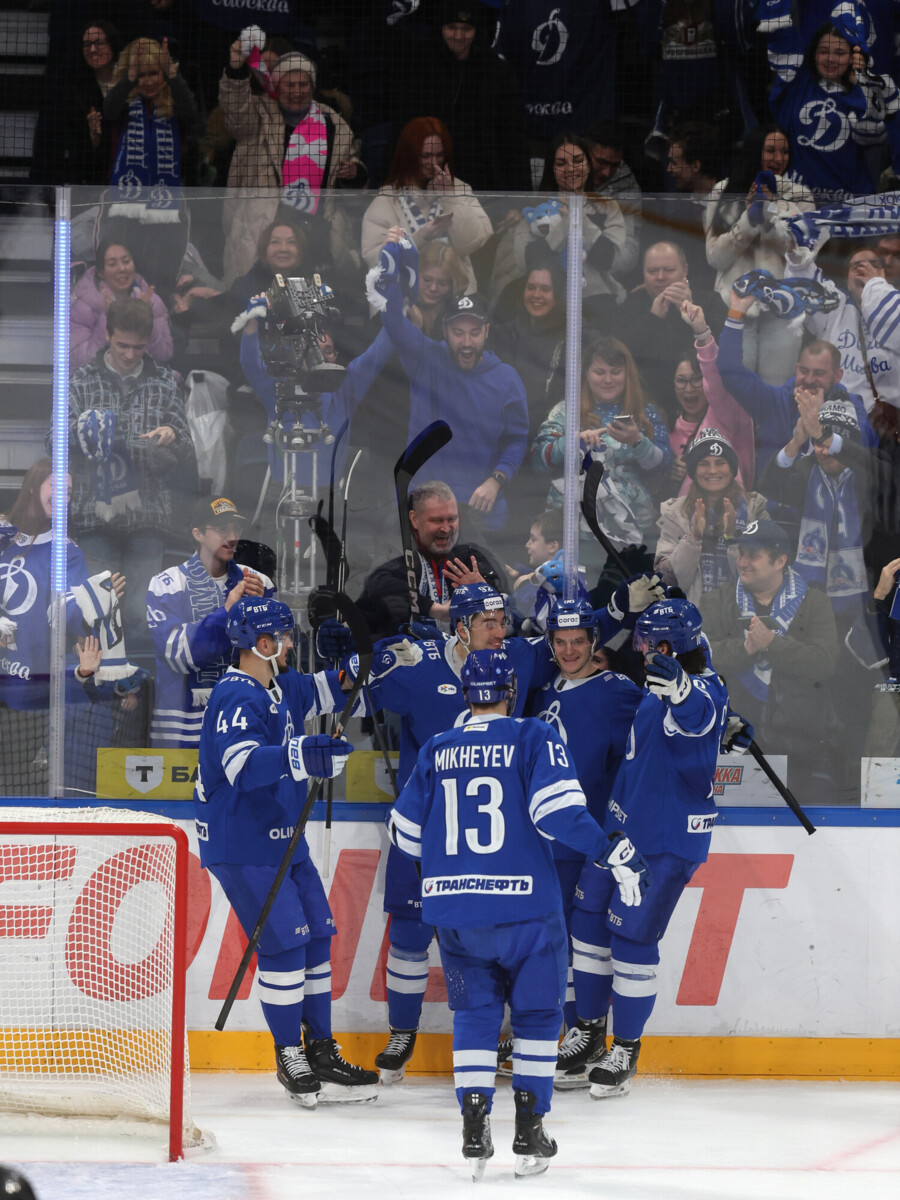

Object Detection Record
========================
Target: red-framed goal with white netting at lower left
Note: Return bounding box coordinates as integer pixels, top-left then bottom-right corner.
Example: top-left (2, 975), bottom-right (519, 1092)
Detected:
top-left (0, 808), bottom-right (202, 1160)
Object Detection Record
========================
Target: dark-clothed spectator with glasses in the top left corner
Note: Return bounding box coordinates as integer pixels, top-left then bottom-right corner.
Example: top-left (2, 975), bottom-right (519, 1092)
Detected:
top-left (30, 19), bottom-right (121, 186)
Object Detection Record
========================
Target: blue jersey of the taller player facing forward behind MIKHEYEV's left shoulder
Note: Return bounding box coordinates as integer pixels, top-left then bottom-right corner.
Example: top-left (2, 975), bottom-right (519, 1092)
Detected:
top-left (370, 637), bottom-right (554, 786)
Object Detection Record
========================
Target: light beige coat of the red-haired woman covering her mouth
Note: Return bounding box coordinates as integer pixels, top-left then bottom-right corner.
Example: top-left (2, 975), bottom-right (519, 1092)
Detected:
top-left (362, 179), bottom-right (493, 294)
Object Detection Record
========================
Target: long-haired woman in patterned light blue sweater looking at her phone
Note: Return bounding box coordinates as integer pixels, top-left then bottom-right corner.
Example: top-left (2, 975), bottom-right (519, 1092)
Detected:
top-left (532, 336), bottom-right (672, 546)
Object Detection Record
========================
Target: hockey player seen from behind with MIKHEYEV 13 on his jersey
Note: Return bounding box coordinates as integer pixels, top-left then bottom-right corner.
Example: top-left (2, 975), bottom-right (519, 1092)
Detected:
top-left (389, 649), bottom-right (647, 1178)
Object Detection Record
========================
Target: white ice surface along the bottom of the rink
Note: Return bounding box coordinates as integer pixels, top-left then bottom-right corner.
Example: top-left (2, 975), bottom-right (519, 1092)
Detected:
top-left (0, 1074), bottom-right (900, 1200)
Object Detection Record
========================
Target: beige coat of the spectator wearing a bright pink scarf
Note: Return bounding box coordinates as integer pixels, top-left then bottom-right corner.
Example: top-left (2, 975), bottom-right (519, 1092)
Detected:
top-left (218, 74), bottom-right (359, 284)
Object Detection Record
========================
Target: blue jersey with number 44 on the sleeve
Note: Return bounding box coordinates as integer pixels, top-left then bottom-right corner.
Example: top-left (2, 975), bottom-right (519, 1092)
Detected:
top-left (193, 667), bottom-right (347, 866)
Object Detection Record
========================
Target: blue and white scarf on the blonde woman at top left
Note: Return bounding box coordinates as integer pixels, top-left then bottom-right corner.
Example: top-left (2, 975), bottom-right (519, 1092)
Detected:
top-left (109, 96), bottom-right (181, 224)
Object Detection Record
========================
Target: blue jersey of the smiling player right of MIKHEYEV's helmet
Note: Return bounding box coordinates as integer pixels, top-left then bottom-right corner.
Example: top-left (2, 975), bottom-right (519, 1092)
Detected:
top-left (530, 671), bottom-right (641, 859)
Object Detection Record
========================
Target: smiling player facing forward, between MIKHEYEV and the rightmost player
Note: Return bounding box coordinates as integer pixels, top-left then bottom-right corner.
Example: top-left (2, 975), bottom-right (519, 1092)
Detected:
top-left (530, 600), bottom-right (641, 1088)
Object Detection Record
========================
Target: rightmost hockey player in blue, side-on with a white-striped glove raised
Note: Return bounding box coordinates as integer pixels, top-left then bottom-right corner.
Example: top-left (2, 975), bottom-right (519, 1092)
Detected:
top-left (571, 600), bottom-right (734, 1099)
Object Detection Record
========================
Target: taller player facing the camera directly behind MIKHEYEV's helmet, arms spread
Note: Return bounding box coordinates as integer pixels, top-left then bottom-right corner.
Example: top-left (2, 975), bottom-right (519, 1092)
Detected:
top-left (352, 583), bottom-right (553, 1084)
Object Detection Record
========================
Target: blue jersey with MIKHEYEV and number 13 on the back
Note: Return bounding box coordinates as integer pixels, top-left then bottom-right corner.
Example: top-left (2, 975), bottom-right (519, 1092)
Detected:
top-left (390, 714), bottom-right (608, 929)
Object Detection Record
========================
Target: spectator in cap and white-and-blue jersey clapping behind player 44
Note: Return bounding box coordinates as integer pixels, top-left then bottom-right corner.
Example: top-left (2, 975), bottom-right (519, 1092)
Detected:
top-left (146, 496), bottom-right (275, 749)
